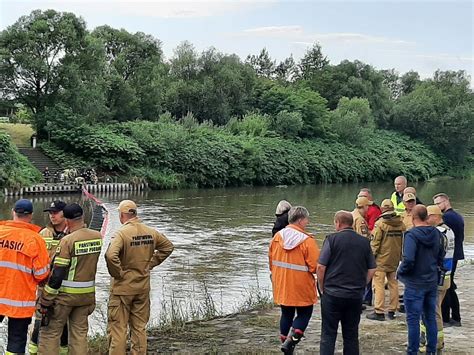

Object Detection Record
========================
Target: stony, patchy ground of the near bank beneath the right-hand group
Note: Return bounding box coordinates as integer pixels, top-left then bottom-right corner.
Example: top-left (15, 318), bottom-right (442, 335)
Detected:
top-left (148, 264), bottom-right (474, 354)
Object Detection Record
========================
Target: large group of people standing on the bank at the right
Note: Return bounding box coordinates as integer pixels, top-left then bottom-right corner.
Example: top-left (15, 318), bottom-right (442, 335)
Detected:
top-left (269, 176), bottom-right (464, 355)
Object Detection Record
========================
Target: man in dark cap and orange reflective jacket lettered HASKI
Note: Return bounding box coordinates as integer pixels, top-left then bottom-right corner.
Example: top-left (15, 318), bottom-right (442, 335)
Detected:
top-left (0, 199), bottom-right (49, 355)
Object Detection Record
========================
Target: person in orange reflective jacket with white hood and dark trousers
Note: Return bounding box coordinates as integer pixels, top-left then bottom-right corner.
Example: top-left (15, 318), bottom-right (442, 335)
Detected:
top-left (268, 206), bottom-right (319, 354)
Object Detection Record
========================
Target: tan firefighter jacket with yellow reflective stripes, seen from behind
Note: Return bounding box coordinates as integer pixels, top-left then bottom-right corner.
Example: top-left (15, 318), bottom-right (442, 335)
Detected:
top-left (40, 227), bottom-right (102, 307)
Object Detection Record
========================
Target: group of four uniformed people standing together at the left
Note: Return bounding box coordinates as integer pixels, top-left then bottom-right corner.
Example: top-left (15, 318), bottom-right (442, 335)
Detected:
top-left (0, 199), bottom-right (174, 355)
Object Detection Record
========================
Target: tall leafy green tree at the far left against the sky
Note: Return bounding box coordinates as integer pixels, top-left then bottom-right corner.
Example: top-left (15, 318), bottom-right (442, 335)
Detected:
top-left (0, 10), bottom-right (90, 113)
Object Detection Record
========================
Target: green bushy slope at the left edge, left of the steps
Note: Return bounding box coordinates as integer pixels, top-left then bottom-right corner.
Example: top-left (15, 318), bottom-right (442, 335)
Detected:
top-left (0, 132), bottom-right (41, 189)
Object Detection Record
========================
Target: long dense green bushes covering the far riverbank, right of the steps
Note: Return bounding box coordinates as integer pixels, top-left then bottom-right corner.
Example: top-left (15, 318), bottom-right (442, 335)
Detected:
top-left (43, 121), bottom-right (445, 188)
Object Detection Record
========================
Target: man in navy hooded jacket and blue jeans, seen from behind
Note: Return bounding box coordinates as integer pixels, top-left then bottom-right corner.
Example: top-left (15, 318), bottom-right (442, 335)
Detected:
top-left (397, 205), bottom-right (444, 355)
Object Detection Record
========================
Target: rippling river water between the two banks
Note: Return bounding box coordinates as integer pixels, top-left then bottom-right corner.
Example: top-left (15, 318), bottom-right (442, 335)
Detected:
top-left (0, 179), bottom-right (474, 334)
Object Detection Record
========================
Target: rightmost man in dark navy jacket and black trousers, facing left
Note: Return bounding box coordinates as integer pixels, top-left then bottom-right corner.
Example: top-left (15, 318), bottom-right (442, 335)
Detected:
top-left (433, 193), bottom-right (464, 327)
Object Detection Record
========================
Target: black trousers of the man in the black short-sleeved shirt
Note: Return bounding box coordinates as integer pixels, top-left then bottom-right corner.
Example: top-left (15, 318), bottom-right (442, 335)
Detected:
top-left (319, 293), bottom-right (362, 355)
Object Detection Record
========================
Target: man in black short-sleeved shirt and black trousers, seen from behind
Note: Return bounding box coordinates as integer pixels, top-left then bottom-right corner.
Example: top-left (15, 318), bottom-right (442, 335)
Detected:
top-left (317, 211), bottom-right (377, 355)
